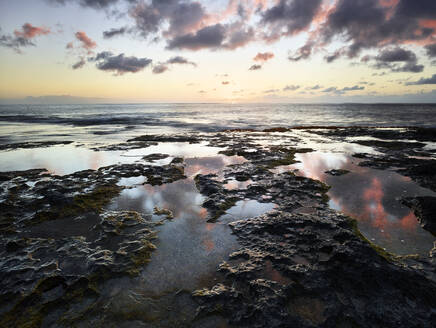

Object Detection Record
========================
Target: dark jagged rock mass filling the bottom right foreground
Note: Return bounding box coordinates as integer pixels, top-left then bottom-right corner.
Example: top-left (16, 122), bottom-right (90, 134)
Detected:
top-left (193, 211), bottom-right (436, 327)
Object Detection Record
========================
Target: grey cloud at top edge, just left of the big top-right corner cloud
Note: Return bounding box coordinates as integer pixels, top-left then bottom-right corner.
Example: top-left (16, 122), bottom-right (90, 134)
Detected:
top-left (261, 0), bottom-right (322, 39)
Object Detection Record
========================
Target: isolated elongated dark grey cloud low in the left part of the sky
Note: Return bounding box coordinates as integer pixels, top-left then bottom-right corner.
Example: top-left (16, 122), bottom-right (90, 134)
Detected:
top-left (89, 51), bottom-right (152, 75)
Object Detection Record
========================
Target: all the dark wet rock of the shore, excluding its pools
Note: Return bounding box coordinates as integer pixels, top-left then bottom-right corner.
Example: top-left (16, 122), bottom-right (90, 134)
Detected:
top-left (0, 128), bottom-right (436, 327)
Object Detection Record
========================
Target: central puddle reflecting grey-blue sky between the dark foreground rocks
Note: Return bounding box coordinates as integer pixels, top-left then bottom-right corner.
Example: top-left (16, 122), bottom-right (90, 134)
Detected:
top-left (110, 179), bottom-right (238, 296)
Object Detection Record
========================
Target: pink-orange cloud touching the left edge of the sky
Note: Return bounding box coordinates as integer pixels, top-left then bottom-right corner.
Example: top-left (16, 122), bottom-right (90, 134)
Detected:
top-left (0, 23), bottom-right (51, 53)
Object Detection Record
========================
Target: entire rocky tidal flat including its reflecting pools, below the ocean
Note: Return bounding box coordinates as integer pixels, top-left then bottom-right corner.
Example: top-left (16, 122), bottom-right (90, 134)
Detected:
top-left (0, 126), bottom-right (436, 327)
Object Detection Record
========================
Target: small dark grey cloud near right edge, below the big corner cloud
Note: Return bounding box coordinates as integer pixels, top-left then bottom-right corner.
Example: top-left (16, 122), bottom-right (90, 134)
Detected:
top-left (374, 47), bottom-right (424, 73)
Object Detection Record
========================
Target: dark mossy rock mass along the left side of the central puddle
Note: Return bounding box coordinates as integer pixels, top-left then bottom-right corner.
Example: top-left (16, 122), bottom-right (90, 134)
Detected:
top-left (0, 164), bottom-right (184, 327)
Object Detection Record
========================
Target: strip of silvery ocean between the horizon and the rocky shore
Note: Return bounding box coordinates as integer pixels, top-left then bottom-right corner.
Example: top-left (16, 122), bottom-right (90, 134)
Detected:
top-left (0, 103), bottom-right (436, 143)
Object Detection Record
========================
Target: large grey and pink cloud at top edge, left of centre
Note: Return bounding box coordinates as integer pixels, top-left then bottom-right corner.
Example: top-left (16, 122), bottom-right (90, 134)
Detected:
top-left (130, 0), bottom-right (255, 50)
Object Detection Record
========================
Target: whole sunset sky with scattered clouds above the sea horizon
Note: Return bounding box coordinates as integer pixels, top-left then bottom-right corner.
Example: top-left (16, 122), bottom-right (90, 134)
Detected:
top-left (0, 0), bottom-right (436, 103)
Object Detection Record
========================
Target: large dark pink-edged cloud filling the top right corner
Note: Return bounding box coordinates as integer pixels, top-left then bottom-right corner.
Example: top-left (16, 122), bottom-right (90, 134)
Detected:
top-left (320, 0), bottom-right (436, 57)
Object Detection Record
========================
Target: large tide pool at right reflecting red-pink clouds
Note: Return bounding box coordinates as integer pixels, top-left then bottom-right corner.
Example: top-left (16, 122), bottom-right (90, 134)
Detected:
top-left (286, 152), bottom-right (436, 256)
